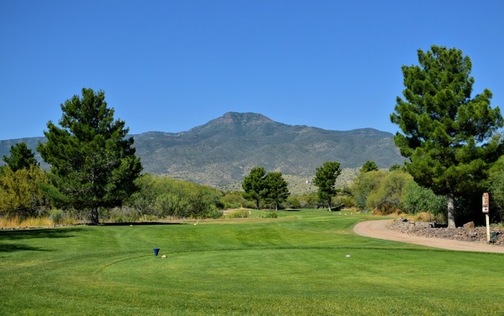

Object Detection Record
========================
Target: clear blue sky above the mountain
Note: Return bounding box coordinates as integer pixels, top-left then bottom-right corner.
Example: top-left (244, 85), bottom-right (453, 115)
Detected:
top-left (0, 0), bottom-right (504, 139)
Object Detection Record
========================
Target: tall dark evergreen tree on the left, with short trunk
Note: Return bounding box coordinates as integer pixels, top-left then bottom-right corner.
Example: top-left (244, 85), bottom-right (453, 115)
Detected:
top-left (37, 89), bottom-right (142, 224)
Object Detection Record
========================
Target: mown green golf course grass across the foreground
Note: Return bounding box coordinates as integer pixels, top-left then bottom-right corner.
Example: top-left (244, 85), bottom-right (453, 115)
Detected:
top-left (0, 210), bottom-right (504, 315)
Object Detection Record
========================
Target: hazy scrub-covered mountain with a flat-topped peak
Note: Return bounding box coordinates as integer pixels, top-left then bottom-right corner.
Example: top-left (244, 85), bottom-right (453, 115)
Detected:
top-left (0, 112), bottom-right (404, 188)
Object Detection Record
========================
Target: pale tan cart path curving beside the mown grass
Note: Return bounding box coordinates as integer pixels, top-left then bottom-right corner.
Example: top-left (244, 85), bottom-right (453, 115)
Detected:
top-left (354, 220), bottom-right (504, 253)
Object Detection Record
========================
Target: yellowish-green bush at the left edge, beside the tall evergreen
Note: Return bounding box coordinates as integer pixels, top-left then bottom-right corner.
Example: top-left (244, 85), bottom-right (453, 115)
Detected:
top-left (0, 165), bottom-right (49, 218)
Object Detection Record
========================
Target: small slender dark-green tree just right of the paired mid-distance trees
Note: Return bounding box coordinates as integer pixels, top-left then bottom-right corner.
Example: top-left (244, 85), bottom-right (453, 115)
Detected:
top-left (313, 161), bottom-right (341, 209)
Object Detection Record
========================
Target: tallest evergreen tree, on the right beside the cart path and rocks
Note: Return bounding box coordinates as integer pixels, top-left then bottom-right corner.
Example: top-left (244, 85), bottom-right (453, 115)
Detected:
top-left (391, 46), bottom-right (503, 227)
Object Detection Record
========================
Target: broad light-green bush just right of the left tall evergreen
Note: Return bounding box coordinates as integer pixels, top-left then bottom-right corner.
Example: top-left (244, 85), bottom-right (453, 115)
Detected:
top-left (127, 174), bottom-right (224, 218)
